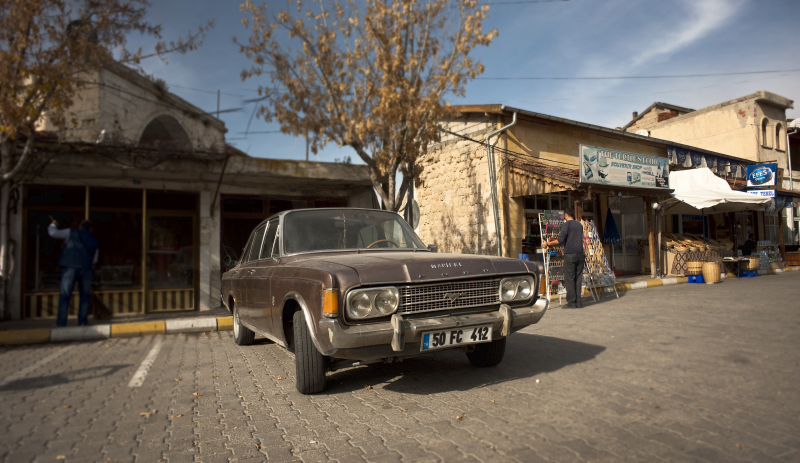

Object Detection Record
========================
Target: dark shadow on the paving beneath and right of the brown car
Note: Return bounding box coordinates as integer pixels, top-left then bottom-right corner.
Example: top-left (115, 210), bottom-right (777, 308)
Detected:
top-left (323, 333), bottom-right (606, 394)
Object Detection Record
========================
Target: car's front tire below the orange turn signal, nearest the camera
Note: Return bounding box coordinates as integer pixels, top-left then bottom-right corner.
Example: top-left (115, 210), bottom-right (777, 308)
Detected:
top-left (292, 311), bottom-right (325, 394)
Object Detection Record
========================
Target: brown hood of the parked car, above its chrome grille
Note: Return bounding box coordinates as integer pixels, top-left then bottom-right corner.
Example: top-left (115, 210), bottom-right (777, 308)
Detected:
top-left (312, 252), bottom-right (528, 285)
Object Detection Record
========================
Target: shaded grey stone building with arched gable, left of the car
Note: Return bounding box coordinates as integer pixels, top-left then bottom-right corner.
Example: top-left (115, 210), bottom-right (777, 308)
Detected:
top-left (4, 64), bottom-right (376, 319)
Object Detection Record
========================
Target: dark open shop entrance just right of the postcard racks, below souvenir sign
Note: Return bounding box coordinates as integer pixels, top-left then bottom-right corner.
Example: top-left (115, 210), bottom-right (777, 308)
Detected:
top-left (608, 196), bottom-right (647, 273)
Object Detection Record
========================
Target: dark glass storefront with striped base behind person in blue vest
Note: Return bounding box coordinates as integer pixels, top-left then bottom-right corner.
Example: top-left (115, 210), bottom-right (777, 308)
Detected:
top-left (23, 185), bottom-right (199, 318)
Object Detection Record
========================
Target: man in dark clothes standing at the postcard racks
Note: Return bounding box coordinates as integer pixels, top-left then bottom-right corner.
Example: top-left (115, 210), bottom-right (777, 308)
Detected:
top-left (542, 207), bottom-right (586, 309)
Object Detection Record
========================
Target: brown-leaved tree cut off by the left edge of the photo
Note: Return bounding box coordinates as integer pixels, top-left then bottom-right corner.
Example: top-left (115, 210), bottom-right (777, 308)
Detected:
top-left (0, 0), bottom-right (213, 316)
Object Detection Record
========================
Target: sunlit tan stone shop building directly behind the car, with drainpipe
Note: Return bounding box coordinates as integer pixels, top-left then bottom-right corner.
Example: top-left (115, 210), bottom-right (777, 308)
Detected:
top-left (415, 105), bottom-right (748, 272)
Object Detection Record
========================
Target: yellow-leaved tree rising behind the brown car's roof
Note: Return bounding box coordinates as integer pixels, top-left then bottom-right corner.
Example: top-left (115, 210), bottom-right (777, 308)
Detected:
top-left (237, 0), bottom-right (497, 210)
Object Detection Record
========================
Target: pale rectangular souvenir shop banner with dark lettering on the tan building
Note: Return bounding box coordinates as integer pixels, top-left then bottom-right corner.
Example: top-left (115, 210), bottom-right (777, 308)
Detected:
top-left (578, 145), bottom-right (669, 188)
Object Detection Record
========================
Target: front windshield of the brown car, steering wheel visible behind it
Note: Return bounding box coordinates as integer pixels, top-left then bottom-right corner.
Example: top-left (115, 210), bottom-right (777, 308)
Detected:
top-left (283, 209), bottom-right (426, 254)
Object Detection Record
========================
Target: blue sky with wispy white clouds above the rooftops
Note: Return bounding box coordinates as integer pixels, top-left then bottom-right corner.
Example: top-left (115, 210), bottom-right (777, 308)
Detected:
top-left (122, 0), bottom-right (800, 162)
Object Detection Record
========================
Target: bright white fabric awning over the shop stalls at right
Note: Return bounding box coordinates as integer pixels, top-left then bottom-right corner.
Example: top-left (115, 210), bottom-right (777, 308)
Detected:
top-left (661, 167), bottom-right (772, 214)
